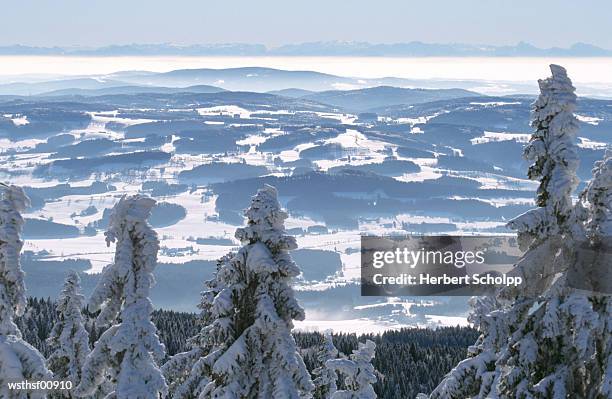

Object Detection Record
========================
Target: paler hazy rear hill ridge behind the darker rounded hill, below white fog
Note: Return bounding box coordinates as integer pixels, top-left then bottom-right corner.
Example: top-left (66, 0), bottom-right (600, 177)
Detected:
top-left (0, 67), bottom-right (486, 96)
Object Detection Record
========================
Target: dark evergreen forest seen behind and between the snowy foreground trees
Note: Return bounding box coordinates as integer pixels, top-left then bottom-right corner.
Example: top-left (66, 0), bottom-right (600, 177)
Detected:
top-left (16, 298), bottom-right (478, 399)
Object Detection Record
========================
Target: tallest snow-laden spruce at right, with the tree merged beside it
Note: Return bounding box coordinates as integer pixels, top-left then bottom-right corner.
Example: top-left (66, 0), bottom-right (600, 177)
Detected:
top-left (431, 66), bottom-right (612, 399)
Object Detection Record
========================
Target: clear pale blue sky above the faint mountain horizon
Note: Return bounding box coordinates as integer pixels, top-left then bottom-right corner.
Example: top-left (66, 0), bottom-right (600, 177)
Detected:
top-left (0, 0), bottom-right (612, 48)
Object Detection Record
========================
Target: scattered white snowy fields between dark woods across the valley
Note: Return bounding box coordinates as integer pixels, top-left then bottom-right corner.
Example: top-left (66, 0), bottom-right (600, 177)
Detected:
top-left (0, 94), bottom-right (607, 332)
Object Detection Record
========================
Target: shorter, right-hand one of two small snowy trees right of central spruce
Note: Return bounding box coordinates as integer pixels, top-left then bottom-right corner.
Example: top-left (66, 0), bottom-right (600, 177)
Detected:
top-left (325, 340), bottom-right (376, 399)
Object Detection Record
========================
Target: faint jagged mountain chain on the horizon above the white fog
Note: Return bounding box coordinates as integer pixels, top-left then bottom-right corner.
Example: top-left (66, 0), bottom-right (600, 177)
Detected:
top-left (0, 41), bottom-right (612, 57)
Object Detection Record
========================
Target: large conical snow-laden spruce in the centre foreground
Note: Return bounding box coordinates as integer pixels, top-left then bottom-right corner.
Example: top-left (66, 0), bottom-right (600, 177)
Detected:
top-left (165, 185), bottom-right (314, 399)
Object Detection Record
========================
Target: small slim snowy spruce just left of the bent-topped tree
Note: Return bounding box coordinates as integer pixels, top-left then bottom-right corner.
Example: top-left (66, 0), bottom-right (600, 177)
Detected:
top-left (47, 271), bottom-right (91, 398)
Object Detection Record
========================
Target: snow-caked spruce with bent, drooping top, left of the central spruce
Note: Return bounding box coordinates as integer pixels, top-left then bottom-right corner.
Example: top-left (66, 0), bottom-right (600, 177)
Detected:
top-left (76, 195), bottom-right (168, 399)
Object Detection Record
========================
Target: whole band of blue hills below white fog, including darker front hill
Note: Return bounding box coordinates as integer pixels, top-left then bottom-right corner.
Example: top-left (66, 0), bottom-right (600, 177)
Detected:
top-left (0, 67), bottom-right (612, 99)
